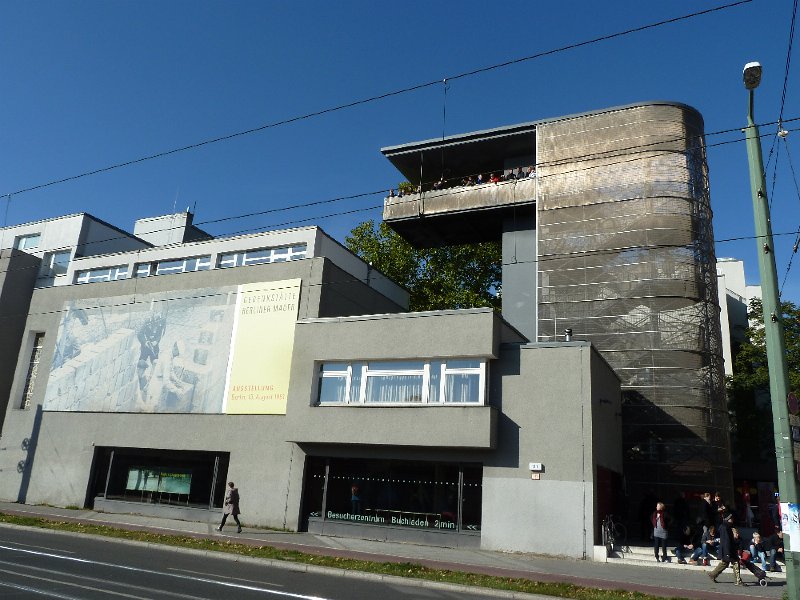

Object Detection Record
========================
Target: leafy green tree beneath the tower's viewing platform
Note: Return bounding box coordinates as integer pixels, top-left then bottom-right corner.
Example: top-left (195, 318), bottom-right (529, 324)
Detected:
top-left (345, 220), bottom-right (501, 311)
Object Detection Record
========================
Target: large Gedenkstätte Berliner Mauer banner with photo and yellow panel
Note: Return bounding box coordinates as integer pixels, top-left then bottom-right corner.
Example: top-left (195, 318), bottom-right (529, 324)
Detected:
top-left (43, 279), bottom-right (300, 414)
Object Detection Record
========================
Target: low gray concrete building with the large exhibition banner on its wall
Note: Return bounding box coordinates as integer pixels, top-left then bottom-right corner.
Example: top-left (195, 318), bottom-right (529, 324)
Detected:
top-left (0, 205), bottom-right (622, 558)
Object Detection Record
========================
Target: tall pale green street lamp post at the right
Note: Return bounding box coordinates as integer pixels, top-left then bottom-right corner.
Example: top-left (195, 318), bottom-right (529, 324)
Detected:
top-left (743, 62), bottom-right (800, 600)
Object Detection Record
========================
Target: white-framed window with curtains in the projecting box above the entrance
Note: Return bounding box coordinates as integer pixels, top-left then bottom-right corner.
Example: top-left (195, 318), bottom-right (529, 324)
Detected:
top-left (319, 359), bottom-right (486, 405)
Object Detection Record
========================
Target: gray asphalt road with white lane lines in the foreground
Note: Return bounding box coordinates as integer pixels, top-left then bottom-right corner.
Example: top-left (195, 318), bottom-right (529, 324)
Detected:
top-left (0, 527), bottom-right (520, 600)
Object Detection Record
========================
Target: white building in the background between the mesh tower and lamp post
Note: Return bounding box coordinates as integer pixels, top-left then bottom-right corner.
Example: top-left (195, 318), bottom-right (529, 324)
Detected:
top-left (717, 258), bottom-right (761, 375)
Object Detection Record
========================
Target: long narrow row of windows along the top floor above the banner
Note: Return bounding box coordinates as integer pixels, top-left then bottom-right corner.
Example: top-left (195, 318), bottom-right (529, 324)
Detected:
top-left (75, 244), bottom-right (307, 283)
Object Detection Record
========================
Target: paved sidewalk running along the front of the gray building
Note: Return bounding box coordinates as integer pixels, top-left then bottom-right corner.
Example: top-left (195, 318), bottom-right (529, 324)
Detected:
top-left (0, 502), bottom-right (786, 600)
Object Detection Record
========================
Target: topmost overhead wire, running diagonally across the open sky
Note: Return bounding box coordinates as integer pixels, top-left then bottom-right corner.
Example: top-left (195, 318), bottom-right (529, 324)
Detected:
top-left (3, 0), bottom-right (753, 196)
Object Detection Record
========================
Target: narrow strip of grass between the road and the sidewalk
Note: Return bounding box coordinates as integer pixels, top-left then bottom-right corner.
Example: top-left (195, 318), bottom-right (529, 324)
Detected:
top-left (0, 513), bottom-right (692, 600)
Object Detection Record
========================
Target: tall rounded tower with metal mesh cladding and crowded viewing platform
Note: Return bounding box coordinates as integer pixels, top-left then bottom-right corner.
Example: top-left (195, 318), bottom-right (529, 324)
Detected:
top-left (382, 102), bottom-right (732, 521)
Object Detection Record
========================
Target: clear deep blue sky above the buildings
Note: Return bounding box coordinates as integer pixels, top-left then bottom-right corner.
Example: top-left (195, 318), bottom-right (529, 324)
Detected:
top-left (0, 0), bottom-right (800, 302)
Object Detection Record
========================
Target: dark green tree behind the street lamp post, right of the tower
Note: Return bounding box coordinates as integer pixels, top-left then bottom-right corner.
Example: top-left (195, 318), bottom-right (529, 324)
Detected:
top-left (727, 298), bottom-right (800, 459)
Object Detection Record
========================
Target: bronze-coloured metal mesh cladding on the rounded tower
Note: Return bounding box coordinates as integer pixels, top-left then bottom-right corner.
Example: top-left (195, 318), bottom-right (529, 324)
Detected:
top-left (537, 105), bottom-right (732, 501)
